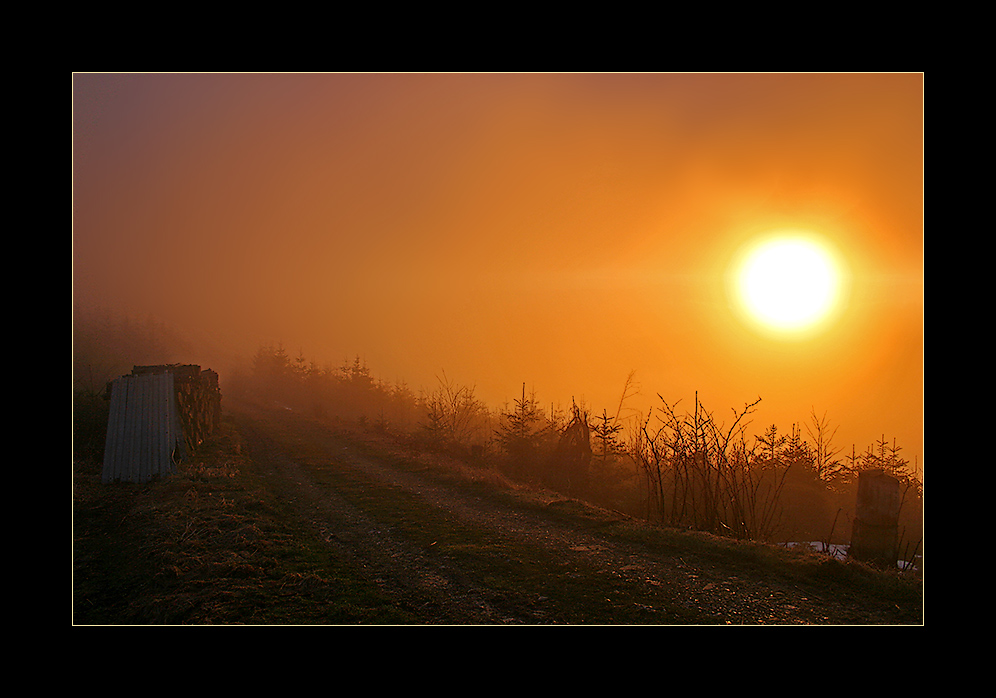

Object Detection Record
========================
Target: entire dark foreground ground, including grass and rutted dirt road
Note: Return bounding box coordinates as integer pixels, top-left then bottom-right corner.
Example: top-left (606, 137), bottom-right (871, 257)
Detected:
top-left (72, 406), bottom-right (923, 625)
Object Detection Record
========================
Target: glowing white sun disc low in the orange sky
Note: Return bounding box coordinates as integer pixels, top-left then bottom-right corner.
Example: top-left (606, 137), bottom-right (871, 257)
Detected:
top-left (734, 232), bottom-right (842, 335)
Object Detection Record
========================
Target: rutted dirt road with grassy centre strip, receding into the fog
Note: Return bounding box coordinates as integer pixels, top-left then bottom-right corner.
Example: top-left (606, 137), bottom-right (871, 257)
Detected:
top-left (235, 406), bottom-right (922, 625)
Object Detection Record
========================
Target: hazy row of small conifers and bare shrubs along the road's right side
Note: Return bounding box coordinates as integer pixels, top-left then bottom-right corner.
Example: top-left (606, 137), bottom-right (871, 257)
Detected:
top-left (233, 346), bottom-right (923, 543)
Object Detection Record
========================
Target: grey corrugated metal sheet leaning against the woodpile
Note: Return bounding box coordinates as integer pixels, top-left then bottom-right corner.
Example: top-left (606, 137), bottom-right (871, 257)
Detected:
top-left (101, 373), bottom-right (184, 483)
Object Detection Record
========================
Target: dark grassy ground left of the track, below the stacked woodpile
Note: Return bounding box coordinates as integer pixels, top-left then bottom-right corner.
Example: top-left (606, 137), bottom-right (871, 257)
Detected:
top-left (73, 421), bottom-right (410, 625)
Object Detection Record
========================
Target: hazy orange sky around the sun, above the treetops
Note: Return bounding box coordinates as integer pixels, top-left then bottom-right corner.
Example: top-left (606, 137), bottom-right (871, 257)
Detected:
top-left (73, 74), bottom-right (923, 468)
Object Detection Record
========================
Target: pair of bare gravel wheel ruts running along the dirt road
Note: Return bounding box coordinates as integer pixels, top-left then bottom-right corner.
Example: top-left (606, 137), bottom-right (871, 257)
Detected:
top-left (231, 400), bottom-right (920, 624)
